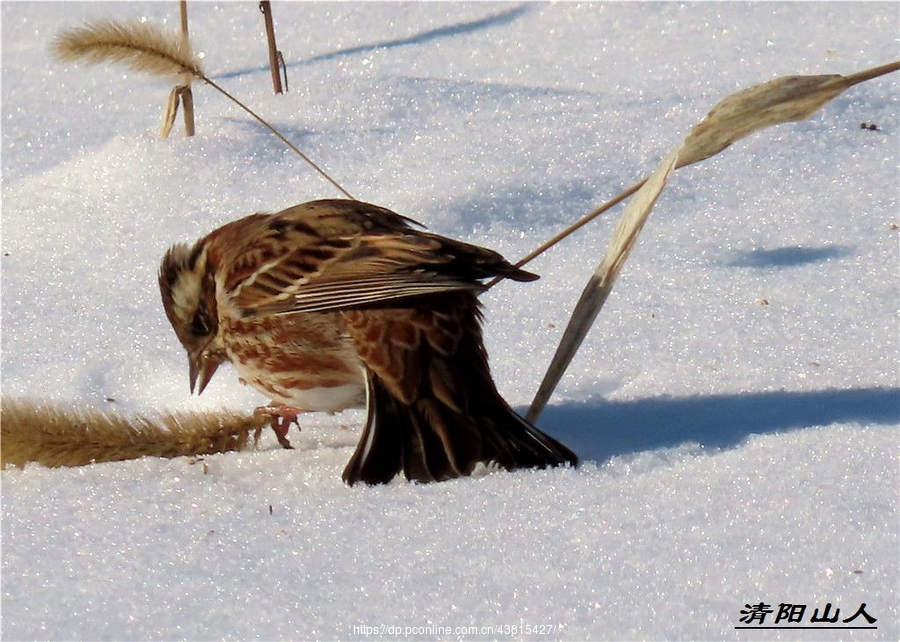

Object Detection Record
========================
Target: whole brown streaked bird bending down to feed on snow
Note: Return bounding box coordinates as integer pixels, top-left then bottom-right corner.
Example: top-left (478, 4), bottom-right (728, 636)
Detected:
top-left (159, 200), bottom-right (578, 485)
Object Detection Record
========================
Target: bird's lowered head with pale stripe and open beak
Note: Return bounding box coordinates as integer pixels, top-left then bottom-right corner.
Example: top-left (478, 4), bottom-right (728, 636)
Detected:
top-left (159, 241), bottom-right (227, 394)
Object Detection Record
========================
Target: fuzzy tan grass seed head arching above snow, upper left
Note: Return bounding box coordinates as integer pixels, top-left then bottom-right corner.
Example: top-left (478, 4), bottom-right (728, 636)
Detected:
top-left (51, 20), bottom-right (203, 77)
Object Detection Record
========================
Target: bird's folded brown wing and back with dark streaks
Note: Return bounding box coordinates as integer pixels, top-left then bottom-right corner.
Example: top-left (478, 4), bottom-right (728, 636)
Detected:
top-left (215, 200), bottom-right (537, 316)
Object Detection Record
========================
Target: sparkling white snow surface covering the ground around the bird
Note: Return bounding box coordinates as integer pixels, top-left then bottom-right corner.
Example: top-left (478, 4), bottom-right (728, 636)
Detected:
top-left (0, 2), bottom-right (900, 640)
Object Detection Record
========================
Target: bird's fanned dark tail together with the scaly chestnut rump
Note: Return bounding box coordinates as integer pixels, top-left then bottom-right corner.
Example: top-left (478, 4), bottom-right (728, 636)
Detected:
top-left (344, 292), bottom-right (578, 485)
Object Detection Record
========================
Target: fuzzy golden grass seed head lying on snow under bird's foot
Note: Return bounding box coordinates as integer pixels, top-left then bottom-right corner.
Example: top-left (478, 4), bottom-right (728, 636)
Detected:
top-left (0, 397), bottom-right (270, 468)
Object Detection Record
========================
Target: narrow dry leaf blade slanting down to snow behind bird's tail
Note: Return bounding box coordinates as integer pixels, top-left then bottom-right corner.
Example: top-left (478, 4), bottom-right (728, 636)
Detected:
top-left (525, 146), bottom-right (681, 421)
